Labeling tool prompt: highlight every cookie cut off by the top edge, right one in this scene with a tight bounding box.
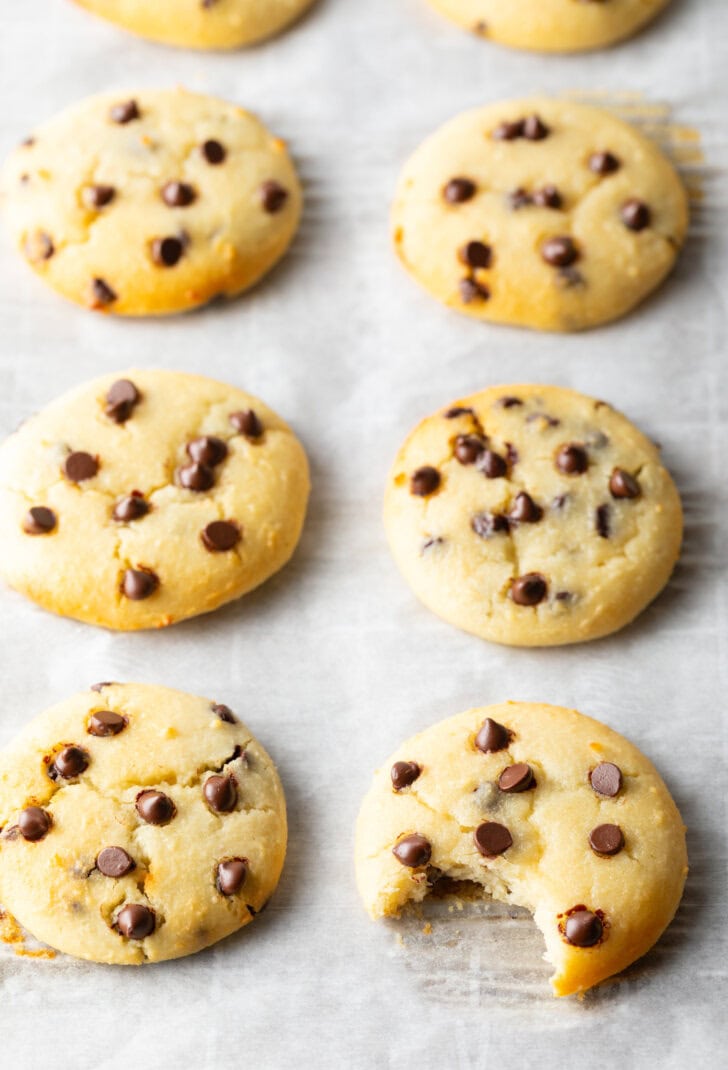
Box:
[429,0,669,52]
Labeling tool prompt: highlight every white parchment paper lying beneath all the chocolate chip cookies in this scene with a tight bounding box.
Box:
[0,0,728,1070]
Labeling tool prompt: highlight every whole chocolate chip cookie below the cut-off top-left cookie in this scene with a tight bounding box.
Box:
[2,89,302,316]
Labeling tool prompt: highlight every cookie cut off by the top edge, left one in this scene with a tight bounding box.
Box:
[71,0,314,48]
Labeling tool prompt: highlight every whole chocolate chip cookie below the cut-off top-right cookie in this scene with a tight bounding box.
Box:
[392,97,687,331]
